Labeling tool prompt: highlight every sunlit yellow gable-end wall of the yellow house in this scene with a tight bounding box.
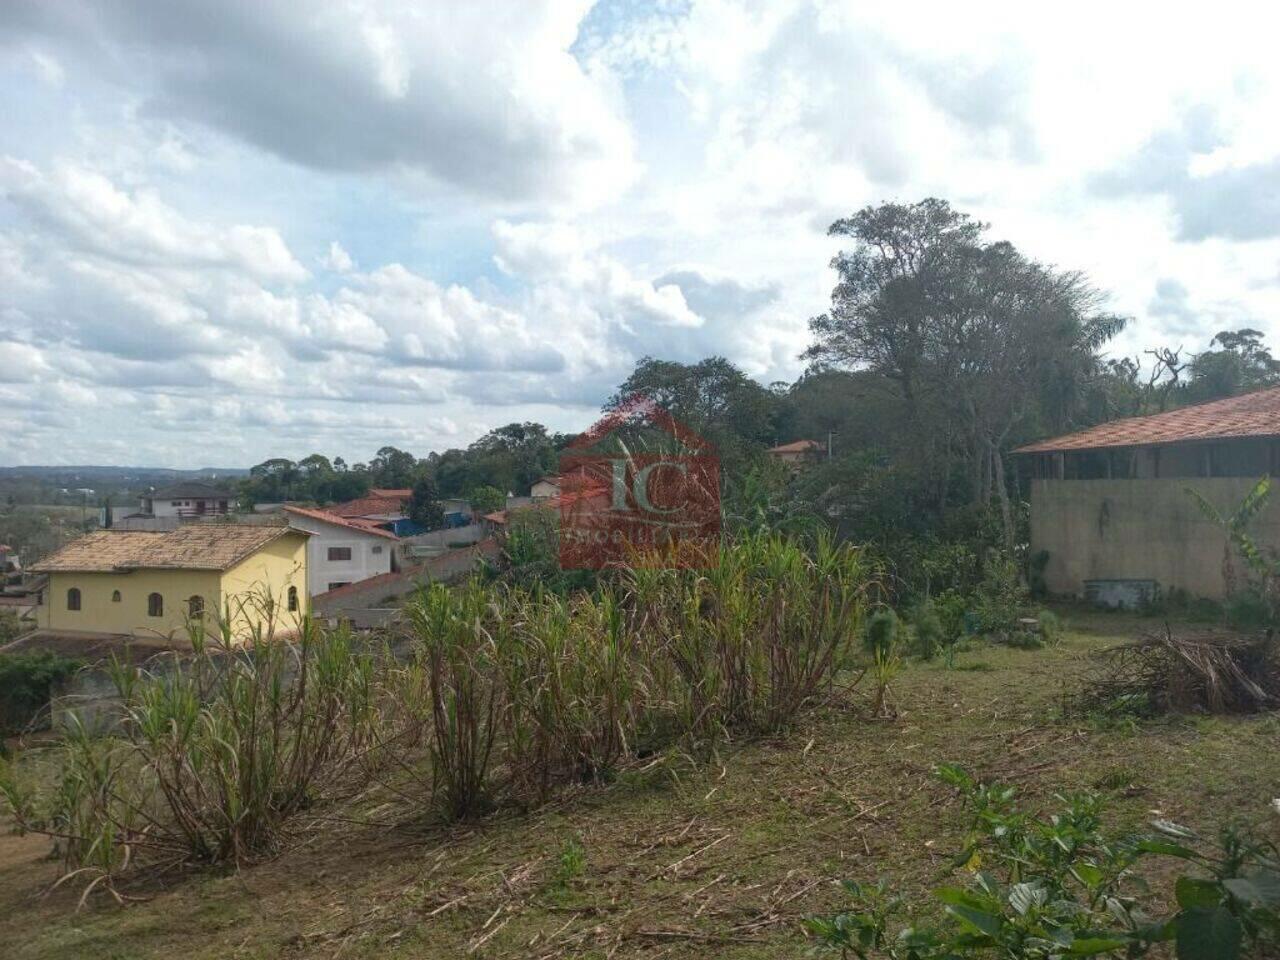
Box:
[220,530,311,639]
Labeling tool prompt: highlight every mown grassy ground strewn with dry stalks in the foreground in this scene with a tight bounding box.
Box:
[0,612,1280,960]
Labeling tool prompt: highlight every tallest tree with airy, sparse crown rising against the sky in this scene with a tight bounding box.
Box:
[805,198,1124,543]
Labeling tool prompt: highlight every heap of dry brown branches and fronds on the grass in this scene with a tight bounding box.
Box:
[1080,626,1280,714]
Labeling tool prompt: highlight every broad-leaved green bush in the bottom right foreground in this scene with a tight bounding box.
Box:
[805,765,1280,960]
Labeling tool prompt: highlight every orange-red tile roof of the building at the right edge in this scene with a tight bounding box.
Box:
[1015,387,1280,453]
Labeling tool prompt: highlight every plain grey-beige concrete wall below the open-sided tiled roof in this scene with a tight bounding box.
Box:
[1032,477,1280,599]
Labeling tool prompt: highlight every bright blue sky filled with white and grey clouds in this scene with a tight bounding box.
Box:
[0,0,1280,468]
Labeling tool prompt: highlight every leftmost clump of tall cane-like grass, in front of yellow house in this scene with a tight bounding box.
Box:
[6,598,376,876]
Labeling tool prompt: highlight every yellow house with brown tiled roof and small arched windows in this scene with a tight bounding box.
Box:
[31,524,311,640]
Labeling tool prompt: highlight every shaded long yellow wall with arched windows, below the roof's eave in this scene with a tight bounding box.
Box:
[37,570,219,637]
